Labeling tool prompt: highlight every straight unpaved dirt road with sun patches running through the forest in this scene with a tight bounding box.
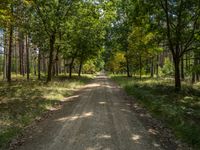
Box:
[17,74,162,150]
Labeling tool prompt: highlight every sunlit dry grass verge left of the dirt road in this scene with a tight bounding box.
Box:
[0,75,92,149]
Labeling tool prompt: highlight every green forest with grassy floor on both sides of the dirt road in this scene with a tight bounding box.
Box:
[0,0,200,149]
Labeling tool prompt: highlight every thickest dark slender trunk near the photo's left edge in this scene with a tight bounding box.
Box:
[7,25,13,82]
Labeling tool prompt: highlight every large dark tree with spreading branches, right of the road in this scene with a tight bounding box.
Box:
[159,0,200,91]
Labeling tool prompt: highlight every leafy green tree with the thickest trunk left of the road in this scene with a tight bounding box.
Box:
[31,0,75,82]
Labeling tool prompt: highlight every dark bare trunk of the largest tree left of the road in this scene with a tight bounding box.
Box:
[47,33,56,82]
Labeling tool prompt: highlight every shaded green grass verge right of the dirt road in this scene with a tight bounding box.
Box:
[111,75,200,149]
